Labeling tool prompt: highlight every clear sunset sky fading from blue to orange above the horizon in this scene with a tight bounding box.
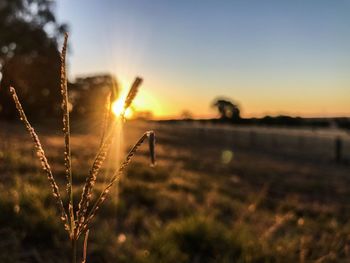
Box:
[56,0,350,118]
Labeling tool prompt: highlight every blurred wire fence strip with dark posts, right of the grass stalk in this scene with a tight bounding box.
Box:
[155,123,350,163]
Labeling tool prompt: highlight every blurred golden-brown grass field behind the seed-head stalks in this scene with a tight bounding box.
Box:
[0,122,350,263]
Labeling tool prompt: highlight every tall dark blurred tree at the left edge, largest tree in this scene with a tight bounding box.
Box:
[0,0,66,118]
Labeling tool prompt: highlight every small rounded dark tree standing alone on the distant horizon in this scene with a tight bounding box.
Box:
[212,98,241,122]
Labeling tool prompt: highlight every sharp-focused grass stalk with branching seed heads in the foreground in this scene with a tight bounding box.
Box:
[10,34,155,263]
